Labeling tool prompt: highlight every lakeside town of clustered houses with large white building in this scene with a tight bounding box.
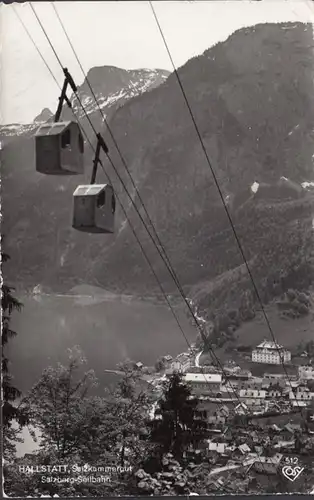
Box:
[129,340,314,492]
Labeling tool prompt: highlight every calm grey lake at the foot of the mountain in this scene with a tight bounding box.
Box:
[8,288,197,455]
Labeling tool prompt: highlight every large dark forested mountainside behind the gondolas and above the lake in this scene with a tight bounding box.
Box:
[3,23,314,320]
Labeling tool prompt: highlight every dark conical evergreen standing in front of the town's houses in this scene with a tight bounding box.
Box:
[151,373,206,461]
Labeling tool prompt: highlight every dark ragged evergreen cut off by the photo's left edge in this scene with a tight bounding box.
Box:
[1,248,27,459]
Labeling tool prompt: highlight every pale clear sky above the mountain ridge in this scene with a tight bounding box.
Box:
[0,0,314,124]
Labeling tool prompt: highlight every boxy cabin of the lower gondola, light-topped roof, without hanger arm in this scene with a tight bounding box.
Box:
[72,184,116,233]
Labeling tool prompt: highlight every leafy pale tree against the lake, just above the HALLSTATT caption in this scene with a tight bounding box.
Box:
[23,346,98,460]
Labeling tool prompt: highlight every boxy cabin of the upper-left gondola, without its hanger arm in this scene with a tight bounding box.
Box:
[35,121,84,175]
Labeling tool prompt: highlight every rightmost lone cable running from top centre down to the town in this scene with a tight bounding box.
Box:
[149,1,302,413]
